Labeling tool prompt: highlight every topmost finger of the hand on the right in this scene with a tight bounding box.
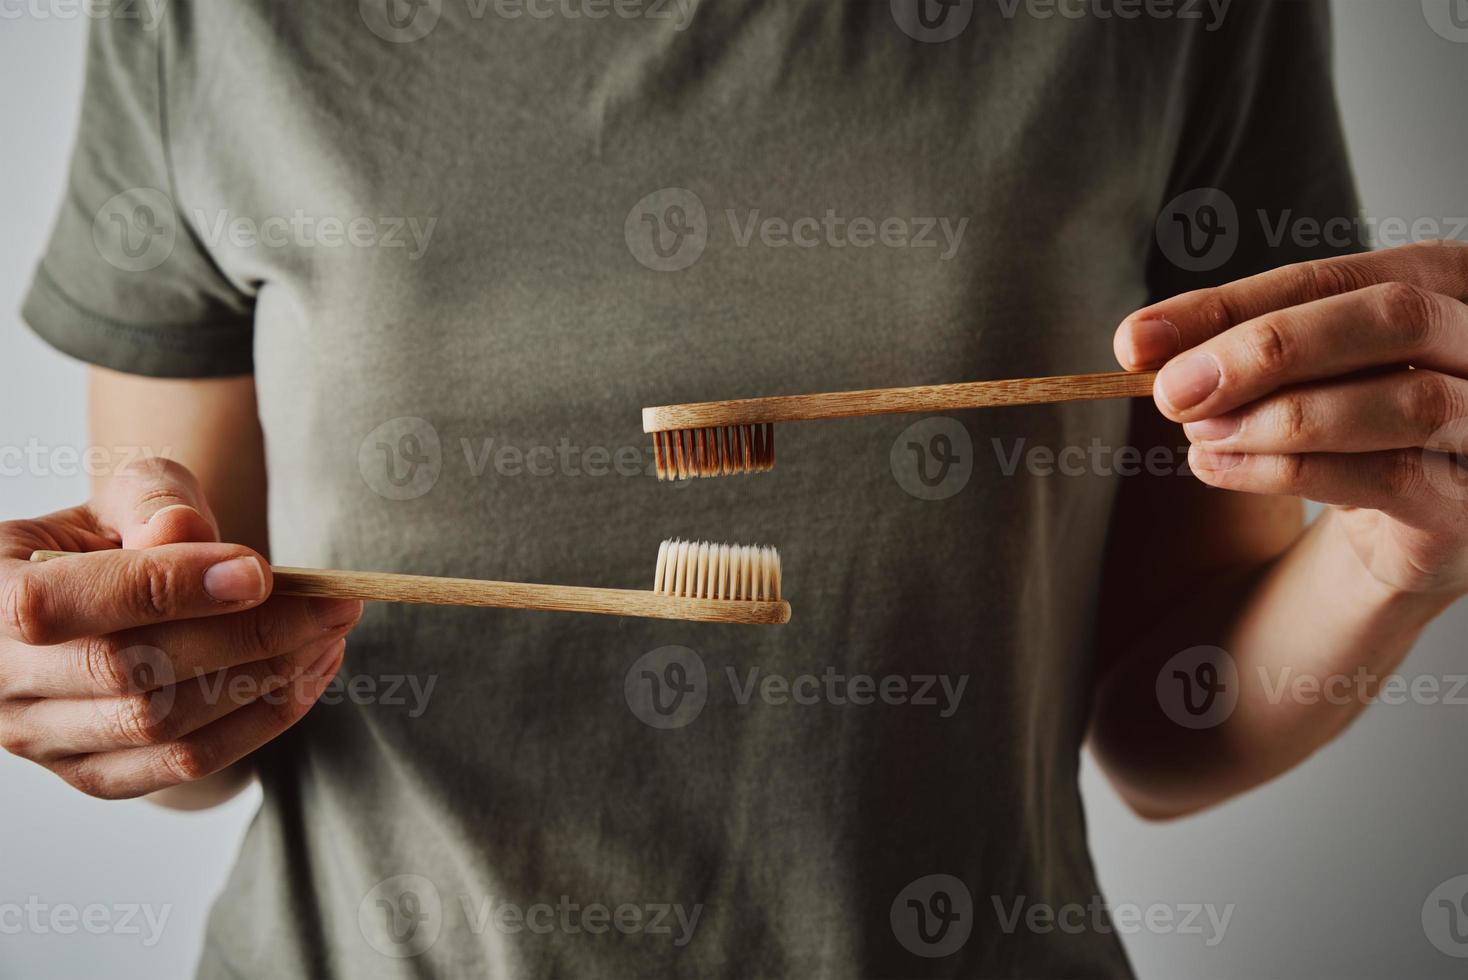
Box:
[1114,241,1468,371]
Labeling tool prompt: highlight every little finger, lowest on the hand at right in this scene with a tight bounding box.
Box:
[1188,446,1462,528]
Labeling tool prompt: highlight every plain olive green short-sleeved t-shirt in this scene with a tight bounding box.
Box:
[25,0,1356,979]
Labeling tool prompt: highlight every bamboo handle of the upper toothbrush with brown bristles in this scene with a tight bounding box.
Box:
[643,371,1157,433]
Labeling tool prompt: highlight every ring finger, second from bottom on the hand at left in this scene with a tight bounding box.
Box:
[0,635,345,764]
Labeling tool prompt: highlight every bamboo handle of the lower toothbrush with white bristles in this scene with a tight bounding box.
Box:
[31,552,790,625]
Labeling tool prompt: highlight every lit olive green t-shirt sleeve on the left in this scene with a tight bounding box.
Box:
[21,18,254,377]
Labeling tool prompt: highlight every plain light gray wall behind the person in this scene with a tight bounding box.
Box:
[0,0,1468,980]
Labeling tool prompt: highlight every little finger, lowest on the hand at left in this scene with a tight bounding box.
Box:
[50,646,342,800]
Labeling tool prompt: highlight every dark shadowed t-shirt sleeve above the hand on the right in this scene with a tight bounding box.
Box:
[1148,0,1367,299]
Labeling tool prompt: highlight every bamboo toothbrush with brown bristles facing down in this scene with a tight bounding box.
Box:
[643,371,1157,480]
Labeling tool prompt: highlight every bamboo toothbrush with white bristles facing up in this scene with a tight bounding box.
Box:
[31,538,790,625]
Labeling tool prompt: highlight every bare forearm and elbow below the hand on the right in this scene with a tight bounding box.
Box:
[1092,511,1456,817]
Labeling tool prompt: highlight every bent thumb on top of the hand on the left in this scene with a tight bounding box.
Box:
[92,456,219,549]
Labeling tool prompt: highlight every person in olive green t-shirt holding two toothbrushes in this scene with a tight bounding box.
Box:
[0,0,1468,977]
